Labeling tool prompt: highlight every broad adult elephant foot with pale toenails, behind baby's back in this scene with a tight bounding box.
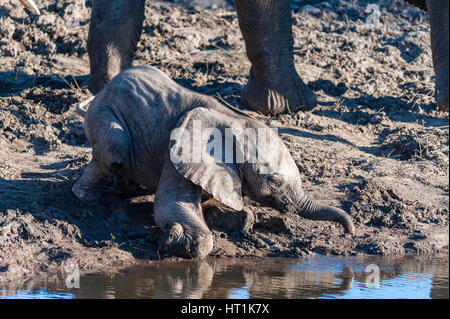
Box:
[242,70,317,115]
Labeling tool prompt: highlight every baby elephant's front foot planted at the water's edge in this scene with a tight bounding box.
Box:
[159,223,213,258]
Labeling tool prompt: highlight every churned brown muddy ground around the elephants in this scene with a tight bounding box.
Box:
[0,0,449,283]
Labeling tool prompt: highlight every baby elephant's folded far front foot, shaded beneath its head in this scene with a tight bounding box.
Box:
[202,203,255,233]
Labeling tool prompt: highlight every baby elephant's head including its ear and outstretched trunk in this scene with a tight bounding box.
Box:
[170,107,354,233]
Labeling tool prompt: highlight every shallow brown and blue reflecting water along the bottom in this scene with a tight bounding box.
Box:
[0,256,449,299]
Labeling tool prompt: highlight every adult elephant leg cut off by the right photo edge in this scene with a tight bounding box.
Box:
[427,0,449,112]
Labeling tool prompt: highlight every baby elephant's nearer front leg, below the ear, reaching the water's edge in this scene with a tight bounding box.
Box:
[153,160,213,258]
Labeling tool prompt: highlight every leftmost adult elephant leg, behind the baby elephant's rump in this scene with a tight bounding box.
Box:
[87,0,145,94]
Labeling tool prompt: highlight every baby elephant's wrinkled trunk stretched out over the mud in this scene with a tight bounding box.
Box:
[297,196,355,234]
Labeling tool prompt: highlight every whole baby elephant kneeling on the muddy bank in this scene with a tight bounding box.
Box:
[73,67,354,258]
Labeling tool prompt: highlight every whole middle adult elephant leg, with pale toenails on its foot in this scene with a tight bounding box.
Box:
[235,0,317,114]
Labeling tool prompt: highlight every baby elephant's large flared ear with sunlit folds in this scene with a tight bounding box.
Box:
[169,107,243,211]
